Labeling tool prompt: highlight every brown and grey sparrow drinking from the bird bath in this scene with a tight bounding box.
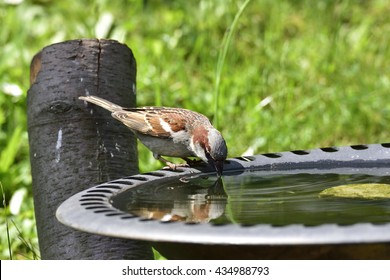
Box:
[79,95,227,176]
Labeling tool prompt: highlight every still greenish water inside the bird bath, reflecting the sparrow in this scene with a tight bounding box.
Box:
[111,171,390,226]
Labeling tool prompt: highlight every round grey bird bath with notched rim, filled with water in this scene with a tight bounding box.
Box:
[57,144,390,259]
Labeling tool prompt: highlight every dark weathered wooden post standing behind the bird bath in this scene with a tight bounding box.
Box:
[27,39,153,259]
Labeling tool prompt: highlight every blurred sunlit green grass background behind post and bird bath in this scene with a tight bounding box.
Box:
[0,0,390,259]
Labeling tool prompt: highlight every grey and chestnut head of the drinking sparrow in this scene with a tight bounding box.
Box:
[191,126,228,176]
